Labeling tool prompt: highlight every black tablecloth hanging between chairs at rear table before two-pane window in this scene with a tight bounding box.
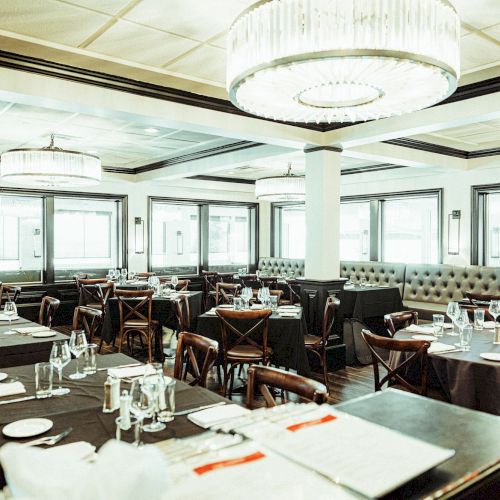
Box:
[95,292,203,343]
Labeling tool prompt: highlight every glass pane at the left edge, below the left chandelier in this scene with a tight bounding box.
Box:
[0,195,44,283]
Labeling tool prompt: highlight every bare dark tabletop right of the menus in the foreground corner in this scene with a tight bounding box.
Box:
[335,390,500,500]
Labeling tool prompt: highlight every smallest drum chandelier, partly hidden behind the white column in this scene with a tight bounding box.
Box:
[255,163,306,201]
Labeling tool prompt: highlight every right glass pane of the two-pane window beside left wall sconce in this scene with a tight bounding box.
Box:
[208,205,250,271]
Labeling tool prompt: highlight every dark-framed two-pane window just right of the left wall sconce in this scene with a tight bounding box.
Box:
[149,198,257,275]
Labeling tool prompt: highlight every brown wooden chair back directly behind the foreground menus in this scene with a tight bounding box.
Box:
[247,365,328,409]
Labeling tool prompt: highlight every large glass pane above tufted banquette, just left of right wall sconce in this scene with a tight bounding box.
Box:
[382,196,439,264]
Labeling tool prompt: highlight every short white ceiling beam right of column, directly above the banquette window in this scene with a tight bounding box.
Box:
[342,142,467,170]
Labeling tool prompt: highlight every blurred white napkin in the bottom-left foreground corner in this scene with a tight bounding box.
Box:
[0,440,169,500]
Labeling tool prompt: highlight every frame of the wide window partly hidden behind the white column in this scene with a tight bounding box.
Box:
[271,188,444,264]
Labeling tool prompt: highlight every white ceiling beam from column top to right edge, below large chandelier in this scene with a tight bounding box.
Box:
[323,92,500,149]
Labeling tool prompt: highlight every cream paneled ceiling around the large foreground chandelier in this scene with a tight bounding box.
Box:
[0,0,500,92]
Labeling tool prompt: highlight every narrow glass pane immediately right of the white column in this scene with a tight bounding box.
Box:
[340,201,370,260]
